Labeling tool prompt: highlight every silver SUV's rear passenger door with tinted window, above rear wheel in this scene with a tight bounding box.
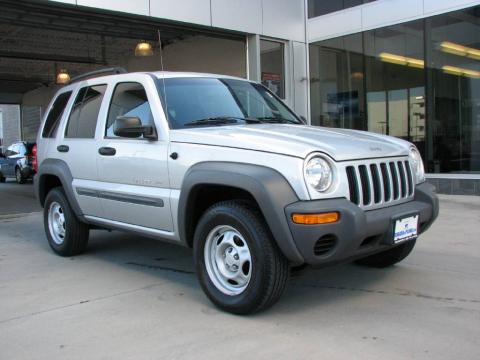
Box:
[51,80,107,217]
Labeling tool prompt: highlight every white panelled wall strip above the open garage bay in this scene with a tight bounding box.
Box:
[50,0,305,42]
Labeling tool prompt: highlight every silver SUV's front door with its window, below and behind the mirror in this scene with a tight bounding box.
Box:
[96,74,173,232]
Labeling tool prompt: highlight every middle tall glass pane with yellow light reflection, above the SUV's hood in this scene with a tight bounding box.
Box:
[364,20,425,152]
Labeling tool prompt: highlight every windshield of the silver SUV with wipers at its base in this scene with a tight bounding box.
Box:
[159,78,302,129]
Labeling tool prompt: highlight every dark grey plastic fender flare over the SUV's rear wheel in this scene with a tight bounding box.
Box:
[34,159,83,219]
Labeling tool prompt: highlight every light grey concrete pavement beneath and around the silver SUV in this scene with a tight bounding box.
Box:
[0,196,480,360]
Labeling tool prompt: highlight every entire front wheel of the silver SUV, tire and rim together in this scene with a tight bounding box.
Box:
[194,201,289,314]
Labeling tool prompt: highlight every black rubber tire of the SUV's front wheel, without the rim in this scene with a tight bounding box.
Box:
[194,201,290,314]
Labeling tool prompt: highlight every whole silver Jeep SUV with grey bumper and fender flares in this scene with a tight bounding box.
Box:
[35,72,438,314]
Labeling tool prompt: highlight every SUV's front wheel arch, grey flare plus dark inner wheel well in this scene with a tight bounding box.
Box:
[177,162,303,263]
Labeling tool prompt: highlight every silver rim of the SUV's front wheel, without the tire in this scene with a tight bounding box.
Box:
[204,225,252,296]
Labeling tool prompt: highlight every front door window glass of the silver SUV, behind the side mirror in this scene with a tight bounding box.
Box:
[105,82,154,137]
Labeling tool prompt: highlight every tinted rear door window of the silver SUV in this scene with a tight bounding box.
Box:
[65,85,107,139]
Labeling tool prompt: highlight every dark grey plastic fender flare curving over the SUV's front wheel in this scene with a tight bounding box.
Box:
[178,162,304,264]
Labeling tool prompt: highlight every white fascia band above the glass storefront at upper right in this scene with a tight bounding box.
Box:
[307,0,480,43]
